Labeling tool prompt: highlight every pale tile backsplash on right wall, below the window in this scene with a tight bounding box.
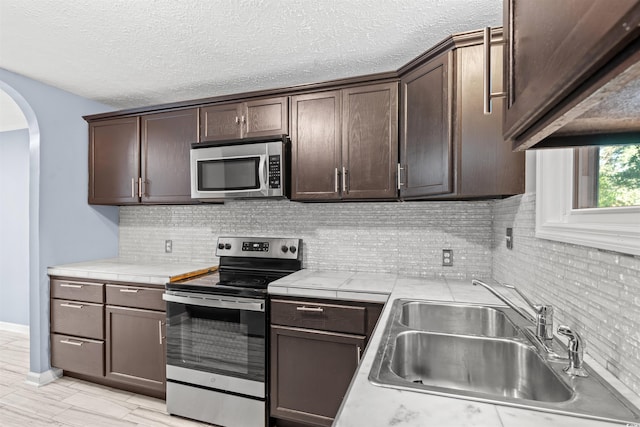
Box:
[493,194,640,394]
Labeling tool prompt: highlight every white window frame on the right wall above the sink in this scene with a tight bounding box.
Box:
[536,148,640,255]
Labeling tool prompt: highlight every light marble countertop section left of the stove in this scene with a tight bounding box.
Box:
[47,258,216,286]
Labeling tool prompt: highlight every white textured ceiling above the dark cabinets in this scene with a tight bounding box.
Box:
[0,0,502,108]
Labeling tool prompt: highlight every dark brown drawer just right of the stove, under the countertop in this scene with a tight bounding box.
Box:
[271,300,367,335]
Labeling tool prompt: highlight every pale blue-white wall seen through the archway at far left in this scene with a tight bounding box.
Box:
[0,129,29,325]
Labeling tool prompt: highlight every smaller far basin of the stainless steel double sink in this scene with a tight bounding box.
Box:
[400,301,518,337]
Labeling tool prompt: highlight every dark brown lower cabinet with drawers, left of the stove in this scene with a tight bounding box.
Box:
[50,277,166,399]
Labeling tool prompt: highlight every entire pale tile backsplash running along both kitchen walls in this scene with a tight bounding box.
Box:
[120,194,640,394]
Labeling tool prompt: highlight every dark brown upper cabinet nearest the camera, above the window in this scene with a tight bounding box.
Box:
[503,0,640,150]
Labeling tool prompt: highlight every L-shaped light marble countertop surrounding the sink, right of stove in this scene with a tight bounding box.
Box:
[269,270,640,427]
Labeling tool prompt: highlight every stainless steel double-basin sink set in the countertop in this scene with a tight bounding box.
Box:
[369,299,640,423]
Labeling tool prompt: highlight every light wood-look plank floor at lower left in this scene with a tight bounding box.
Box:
[0,330,208,427]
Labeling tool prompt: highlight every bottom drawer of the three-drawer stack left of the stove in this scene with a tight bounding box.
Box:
[51,334,104,377]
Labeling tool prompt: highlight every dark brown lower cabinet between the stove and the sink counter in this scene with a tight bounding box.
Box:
[270,298,382,427]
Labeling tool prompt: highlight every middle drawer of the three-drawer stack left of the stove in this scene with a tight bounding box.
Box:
[51,299,104,339]
